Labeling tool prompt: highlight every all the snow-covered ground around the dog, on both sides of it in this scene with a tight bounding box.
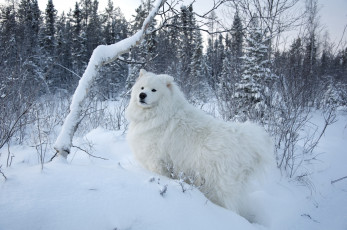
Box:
[0,110,347,230]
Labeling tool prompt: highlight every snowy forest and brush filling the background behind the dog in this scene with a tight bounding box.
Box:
[0,0,347,180]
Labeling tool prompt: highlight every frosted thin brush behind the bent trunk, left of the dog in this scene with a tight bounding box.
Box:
[0,91,128,167]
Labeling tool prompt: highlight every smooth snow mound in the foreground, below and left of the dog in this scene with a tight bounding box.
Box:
[0,129,256,230]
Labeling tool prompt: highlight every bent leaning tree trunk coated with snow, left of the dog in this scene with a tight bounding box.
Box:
[54,0,166,158]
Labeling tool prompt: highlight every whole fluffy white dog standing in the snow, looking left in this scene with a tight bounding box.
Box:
[126,70,273,220]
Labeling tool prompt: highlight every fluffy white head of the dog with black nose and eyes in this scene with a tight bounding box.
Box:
[131,69,173,109]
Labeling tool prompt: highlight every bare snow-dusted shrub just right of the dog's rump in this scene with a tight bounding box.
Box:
[263,74,336,179]
